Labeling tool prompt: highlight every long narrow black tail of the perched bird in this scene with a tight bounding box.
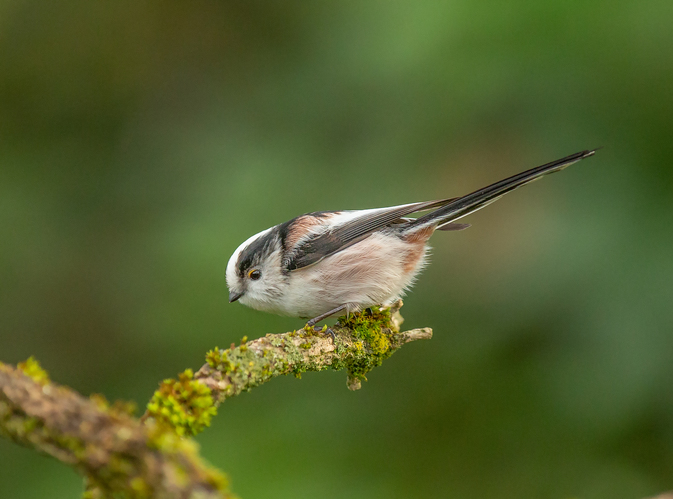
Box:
[412,149,598,227]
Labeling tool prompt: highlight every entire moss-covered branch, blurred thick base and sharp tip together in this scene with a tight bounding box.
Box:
[0,301,432,499]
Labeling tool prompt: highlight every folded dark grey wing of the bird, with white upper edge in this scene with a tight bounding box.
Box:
[284,198,456,271]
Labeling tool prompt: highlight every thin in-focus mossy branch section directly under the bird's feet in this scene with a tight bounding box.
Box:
[143,300,432,435]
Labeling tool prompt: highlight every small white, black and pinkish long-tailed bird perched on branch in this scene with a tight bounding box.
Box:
[226,149,598,326]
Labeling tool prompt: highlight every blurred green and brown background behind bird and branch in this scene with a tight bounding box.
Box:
[0,0,673,499]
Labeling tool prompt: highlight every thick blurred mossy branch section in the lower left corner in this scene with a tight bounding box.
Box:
[0,359,230,499]
